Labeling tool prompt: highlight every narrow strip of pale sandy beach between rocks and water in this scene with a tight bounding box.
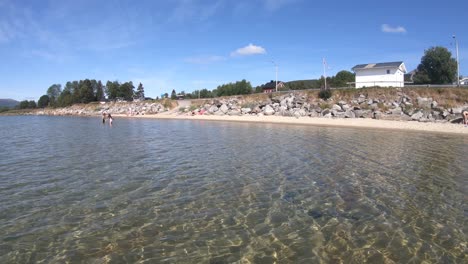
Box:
[117,113,468,135]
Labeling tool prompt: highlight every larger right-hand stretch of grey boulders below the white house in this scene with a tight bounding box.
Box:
[186,92,468,122]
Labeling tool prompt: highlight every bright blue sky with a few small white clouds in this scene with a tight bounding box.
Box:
[0,0,468,100]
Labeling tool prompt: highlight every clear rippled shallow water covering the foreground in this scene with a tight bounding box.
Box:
[0,117,468,263]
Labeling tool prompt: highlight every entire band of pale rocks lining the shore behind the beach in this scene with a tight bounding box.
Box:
[23,91,468,123]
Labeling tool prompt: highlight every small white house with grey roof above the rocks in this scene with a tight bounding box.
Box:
[352,61,406,88]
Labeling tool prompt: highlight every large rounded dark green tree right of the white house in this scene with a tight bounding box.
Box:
[415,46,457,84]
